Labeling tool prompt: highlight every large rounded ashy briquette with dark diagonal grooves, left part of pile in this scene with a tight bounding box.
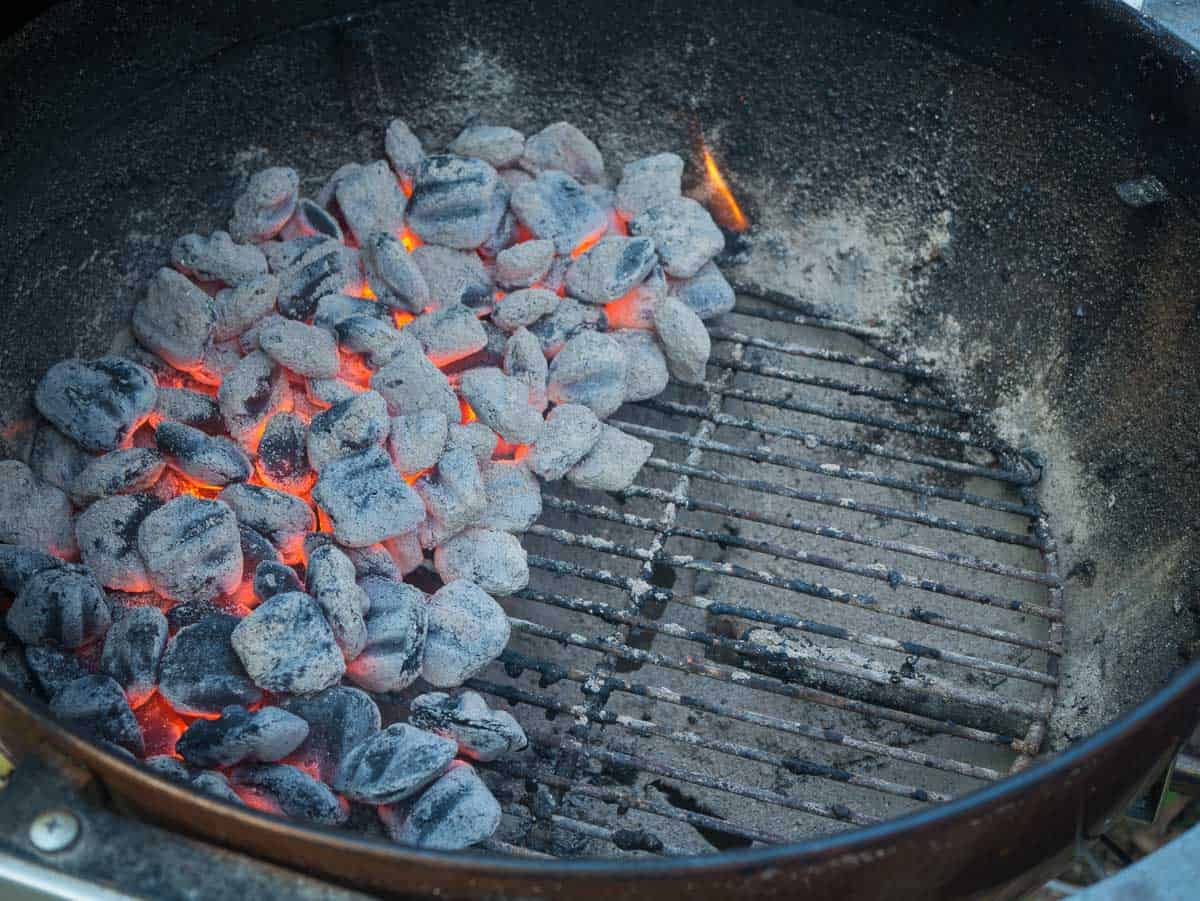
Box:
[138,494,242,601]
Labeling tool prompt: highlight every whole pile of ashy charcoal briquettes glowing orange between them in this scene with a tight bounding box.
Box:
[0,120,733,848]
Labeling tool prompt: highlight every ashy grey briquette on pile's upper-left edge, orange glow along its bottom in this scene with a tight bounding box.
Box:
[135,268,217,374]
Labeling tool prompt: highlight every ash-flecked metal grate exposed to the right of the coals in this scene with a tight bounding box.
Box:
[451,290,1063,855]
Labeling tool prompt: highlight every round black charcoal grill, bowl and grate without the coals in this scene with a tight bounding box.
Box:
[0,0,1200,897]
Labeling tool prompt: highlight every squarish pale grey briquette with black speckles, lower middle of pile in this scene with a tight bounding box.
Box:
[230,591,346,695]
